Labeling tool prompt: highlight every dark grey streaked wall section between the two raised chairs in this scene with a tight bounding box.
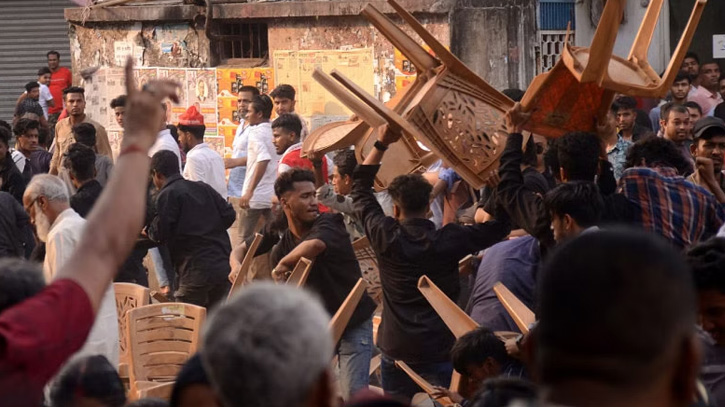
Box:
[450,0,538,89]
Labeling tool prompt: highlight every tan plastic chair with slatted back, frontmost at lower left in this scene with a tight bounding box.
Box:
[126,303,206,399]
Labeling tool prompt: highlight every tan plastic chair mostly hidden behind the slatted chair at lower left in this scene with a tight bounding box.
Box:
[113,283,151,381]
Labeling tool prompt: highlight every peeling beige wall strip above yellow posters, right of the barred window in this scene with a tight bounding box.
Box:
[268,14,450,100]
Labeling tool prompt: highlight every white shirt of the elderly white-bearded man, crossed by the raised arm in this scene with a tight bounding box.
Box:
[43,208,119,366]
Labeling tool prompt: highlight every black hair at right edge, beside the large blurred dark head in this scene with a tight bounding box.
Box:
[687,237,725,294]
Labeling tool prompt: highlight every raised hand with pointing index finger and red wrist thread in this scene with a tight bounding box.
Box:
[122,58,179,151]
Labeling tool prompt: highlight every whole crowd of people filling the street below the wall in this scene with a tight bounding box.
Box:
[0,47,725,407]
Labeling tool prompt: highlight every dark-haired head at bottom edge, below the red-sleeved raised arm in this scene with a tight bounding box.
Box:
[50,355,126,407]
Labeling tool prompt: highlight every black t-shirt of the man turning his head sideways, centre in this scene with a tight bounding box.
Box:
[272,213,375,327]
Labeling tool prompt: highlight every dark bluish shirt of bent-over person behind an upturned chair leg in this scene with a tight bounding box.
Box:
[466,236,541,332]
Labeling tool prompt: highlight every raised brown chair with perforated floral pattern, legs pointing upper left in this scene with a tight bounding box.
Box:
[306,0,513,188]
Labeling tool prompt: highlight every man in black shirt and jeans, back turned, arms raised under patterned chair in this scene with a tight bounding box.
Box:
[352,129,511,399]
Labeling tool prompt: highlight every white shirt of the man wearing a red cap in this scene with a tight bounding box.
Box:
[184,143,227,199]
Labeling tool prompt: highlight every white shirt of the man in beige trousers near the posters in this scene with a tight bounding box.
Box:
[242,122,279,209]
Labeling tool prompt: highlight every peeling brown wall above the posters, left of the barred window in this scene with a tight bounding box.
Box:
[69,23,210,81]
